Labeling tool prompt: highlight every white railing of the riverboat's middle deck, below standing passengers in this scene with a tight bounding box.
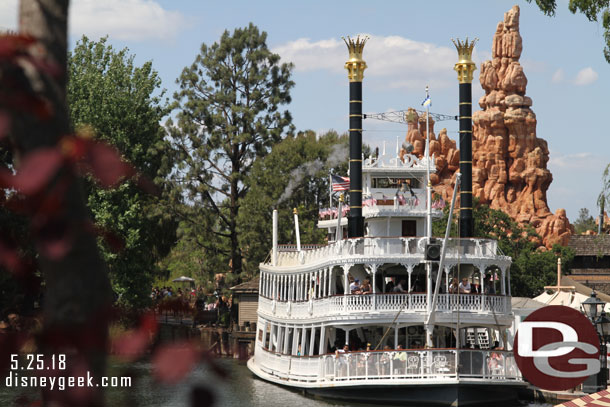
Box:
[258,293,511,319]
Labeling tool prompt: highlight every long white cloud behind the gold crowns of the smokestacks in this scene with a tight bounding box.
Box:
[273,34,464,90]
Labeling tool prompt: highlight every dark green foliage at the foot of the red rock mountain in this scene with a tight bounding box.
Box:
[433,200,574,298]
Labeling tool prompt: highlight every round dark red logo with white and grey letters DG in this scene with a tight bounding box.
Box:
[514,305,600,391]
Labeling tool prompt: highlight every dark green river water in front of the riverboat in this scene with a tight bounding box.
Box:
[0,359,551,407]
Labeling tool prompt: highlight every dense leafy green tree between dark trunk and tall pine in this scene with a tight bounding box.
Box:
[68,37,176,306]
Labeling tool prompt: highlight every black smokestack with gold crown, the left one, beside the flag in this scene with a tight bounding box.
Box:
[343,36,368,237]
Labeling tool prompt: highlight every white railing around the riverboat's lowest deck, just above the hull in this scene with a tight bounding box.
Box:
[255,348,521,384]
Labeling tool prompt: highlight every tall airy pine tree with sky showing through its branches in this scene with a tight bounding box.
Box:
[168,24,294,274]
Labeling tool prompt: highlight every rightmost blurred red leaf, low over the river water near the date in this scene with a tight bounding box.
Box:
[152,342,199,384]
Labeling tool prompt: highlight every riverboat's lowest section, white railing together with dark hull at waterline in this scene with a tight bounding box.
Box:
[248,348,525,407]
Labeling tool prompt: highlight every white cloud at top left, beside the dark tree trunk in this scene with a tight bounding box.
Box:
[0,0,187,41]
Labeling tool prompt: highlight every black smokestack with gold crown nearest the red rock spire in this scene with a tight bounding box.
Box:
[451,37,478,237]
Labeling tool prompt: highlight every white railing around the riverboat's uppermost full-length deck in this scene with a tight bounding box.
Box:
[268,237,498,267]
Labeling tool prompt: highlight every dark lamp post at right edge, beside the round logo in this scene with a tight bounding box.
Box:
[581,291,610,393]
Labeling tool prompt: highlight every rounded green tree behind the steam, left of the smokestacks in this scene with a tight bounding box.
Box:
[238,131,348,277]
